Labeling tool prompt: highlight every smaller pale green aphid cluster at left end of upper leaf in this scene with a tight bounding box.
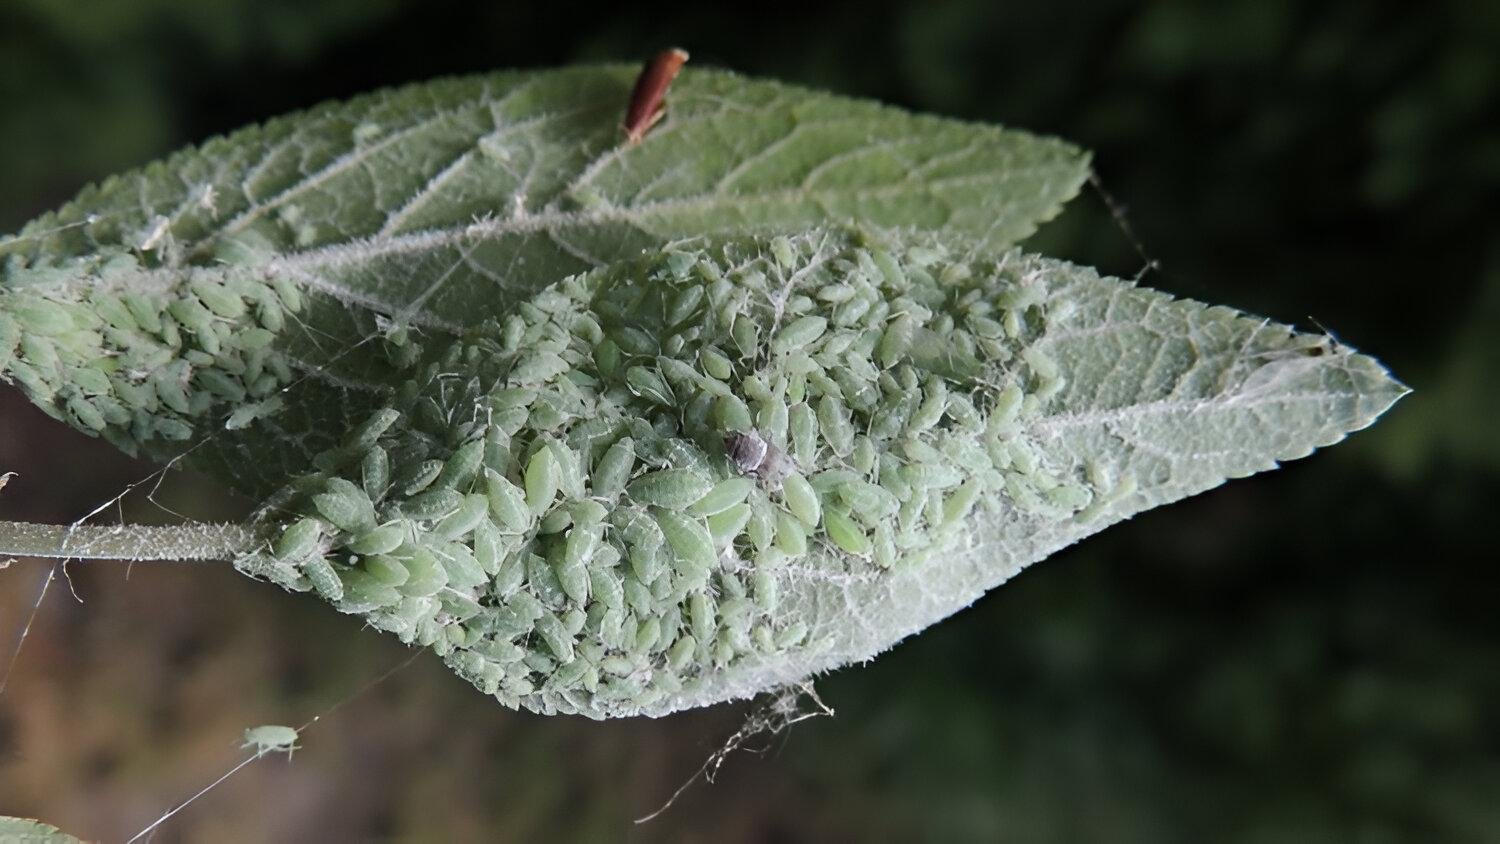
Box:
[0,252,303,454]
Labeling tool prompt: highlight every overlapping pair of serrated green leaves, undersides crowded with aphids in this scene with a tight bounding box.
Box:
[0,67,1404,717]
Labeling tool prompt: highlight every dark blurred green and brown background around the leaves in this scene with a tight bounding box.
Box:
[0,0,1500,844]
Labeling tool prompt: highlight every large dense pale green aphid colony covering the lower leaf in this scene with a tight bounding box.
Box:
[228,234,1095,717]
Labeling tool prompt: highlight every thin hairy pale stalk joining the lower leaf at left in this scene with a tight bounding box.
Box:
[0,522,266,561]
